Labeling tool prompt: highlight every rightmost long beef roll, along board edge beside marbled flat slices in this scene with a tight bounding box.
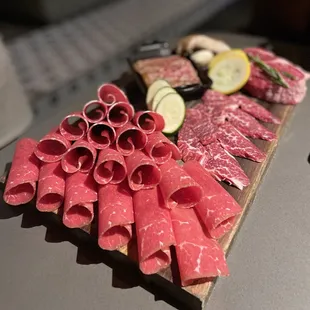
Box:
[183,161,242,239]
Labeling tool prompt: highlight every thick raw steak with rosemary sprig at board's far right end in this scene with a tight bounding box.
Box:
[245,48,310,104]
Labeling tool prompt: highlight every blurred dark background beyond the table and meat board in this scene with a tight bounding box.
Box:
[0,0,310,147]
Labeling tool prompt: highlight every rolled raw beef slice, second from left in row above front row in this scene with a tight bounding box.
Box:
[61,138,97,173]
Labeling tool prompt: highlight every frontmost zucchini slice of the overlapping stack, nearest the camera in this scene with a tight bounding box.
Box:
[156,93,186,134]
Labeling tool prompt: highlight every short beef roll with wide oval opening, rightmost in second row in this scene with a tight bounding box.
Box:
[159,159,202,209]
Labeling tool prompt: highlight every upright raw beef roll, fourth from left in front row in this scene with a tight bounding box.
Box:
[98,181,134,251]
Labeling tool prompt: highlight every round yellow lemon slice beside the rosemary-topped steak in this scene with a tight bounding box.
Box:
[209,50,251,94]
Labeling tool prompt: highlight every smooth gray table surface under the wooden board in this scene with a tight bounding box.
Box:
[0,35,310,310]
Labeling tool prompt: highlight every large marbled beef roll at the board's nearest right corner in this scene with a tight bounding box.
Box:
[171,208,229,286]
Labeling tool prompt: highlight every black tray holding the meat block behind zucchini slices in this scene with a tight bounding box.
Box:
[127,41,212,101]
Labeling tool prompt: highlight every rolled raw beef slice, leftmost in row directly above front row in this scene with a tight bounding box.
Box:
[34,130,71,163]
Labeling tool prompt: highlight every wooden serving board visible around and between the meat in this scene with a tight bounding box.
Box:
[0,77,294,309]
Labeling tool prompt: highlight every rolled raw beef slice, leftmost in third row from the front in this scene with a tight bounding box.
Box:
[59,112,89,141]
